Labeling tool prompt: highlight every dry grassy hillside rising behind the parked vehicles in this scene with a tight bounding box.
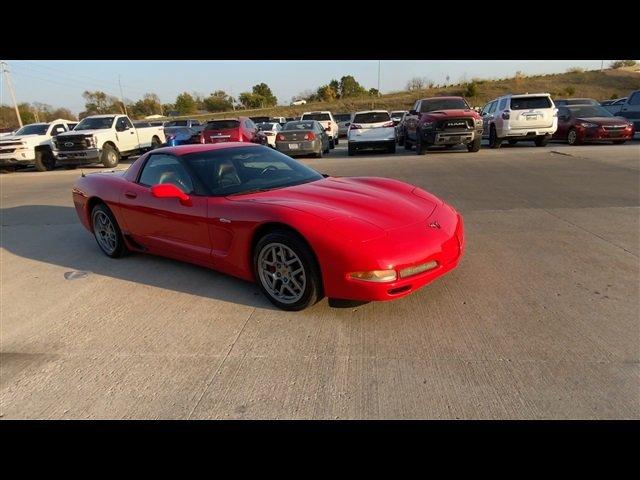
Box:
[166,69,640,123]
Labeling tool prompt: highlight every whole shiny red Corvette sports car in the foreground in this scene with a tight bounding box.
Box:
[73,142,464,310]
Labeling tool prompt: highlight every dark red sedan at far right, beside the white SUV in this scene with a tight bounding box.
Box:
[553,105,634,145]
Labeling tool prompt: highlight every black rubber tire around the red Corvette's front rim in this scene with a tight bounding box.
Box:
[253,230,323,312]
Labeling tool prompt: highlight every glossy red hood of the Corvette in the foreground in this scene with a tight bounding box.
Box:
[233,177,439,231]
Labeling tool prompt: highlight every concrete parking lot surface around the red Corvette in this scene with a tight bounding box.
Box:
[0,141,640,419]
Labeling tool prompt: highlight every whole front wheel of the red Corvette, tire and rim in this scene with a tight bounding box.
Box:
[253,230,322,311]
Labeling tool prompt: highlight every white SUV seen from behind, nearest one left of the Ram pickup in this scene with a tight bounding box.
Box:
[347,110,396,156]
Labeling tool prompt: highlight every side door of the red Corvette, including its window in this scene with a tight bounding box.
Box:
[120,153,211,263]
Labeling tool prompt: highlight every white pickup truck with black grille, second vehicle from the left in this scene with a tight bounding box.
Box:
[53,114,166,168]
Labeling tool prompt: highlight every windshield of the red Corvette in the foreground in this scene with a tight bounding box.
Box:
[182,146,323,195]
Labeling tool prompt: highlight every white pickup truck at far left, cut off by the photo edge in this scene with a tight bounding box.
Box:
[0,118,78,172]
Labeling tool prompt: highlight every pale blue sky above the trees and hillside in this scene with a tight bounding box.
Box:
[0,60,610,114]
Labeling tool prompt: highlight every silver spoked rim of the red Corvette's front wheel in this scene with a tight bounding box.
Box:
[258,243,307,304]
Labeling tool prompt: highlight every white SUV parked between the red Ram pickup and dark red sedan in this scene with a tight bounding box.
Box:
[482,93,558,148]
